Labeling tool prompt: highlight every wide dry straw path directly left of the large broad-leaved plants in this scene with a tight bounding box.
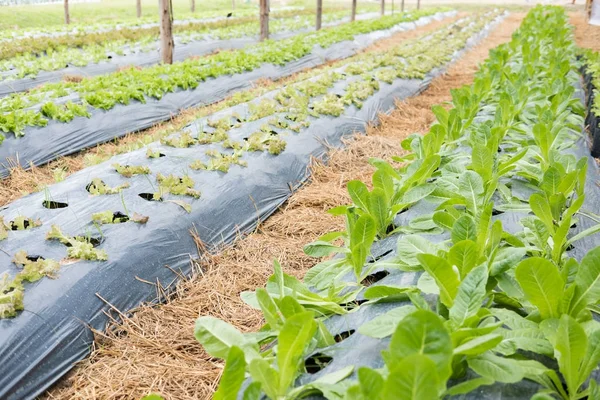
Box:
[46,10,524,400]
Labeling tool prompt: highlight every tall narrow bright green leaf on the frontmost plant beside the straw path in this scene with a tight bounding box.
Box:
[277,312,317,394]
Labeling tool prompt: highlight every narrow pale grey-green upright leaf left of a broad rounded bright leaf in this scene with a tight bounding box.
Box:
[449,265,488,327]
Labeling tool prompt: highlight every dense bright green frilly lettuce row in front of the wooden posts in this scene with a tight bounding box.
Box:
[0,10,446,142]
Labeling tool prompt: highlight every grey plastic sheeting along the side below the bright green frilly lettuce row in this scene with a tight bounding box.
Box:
[0,11,456,177]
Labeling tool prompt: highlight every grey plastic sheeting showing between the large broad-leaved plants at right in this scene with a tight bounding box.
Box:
[262,79,600,400]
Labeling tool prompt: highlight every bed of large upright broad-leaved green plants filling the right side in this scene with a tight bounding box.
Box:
[195,6,600,400]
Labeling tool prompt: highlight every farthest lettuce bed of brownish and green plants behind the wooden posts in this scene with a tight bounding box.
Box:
[0,10,368,81]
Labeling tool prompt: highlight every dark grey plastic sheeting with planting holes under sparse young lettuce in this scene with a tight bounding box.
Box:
[0,36,450,400]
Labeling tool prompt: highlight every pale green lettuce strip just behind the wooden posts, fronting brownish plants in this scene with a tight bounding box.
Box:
[0,11,370,80]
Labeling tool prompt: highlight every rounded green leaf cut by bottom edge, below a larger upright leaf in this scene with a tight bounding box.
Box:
[383,354,440,400]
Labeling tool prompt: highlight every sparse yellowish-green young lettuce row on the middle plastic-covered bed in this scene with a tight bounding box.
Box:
[0,12,499,318]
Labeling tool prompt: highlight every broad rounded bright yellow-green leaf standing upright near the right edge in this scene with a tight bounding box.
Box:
[515,257,565,319]
